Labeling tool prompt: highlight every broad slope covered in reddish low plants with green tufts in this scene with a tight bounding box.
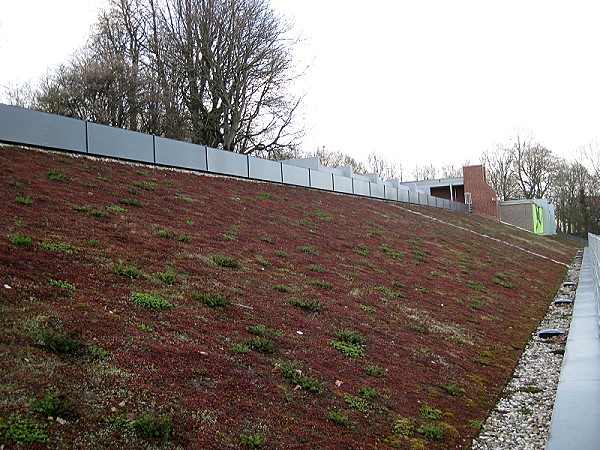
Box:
[0,147,574,448]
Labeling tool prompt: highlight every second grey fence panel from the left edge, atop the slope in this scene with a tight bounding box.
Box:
[88,122,154,163]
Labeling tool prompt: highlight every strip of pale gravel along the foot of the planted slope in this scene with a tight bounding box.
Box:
[471,253,581,450]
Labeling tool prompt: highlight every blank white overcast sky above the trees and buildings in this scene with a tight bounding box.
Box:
[0,0,600,174]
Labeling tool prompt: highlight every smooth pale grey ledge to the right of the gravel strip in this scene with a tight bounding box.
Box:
[546,247,600,450]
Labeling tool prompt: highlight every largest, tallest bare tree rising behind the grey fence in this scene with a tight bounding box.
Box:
[155,0,301,153]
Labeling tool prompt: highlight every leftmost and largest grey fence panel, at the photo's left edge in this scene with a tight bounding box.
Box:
[0,104,86,153]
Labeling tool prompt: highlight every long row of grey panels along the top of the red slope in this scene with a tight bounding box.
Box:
[0,104,468,211]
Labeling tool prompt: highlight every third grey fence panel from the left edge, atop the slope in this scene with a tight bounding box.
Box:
[154,136,206,170]
